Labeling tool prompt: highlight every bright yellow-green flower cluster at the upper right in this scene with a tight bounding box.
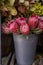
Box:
[30,2,43,16]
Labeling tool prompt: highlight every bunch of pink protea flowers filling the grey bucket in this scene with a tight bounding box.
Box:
[2,14,43,35]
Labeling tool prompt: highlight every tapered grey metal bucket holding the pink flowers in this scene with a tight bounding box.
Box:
[13,34,38,65]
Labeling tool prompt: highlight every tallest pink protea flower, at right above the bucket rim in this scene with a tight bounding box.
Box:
[28,14,38,29]
